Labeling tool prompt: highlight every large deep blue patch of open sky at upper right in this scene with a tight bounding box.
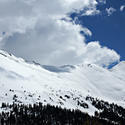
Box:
[72,0,125,60]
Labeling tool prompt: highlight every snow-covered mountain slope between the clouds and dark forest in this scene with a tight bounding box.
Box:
[0,50,125,115]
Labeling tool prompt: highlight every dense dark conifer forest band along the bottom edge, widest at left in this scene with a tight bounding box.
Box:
[0,103,123,125]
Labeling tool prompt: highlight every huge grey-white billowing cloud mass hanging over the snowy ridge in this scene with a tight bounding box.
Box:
[0,0,120,65]
